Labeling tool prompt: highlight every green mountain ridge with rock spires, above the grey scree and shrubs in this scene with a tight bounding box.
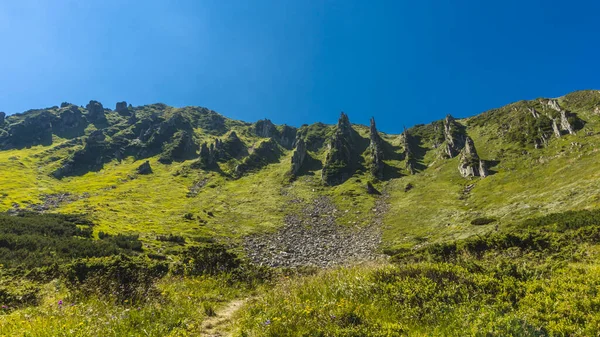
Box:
[0,90,600,253]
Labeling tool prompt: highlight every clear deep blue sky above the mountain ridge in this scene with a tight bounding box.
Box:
[0,0,600,133]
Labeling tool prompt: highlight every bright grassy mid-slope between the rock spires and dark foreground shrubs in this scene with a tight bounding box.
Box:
[0,92,600,253]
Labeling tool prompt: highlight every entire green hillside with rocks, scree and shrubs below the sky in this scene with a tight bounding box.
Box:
[0,90,600,336]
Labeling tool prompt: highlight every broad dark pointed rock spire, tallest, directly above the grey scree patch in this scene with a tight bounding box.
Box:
[321,112,356,185]
